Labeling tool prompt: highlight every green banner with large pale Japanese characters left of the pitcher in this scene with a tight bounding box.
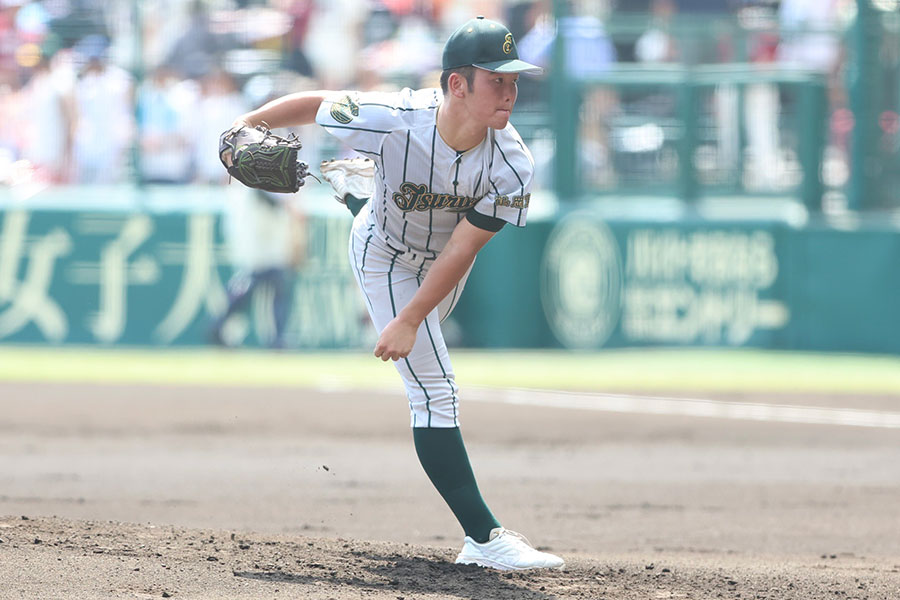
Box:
[0,209,372,348]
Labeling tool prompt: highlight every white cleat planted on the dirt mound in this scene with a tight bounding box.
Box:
[456,527,566,571]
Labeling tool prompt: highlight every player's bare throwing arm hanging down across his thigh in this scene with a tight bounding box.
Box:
[375,219,496,361]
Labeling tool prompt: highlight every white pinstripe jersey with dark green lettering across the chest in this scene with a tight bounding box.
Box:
[316,88,534,258]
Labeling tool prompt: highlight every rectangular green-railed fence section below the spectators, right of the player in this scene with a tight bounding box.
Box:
[553,64,826,210]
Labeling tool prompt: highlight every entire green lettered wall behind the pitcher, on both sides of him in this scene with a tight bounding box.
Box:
[0,190,900,353]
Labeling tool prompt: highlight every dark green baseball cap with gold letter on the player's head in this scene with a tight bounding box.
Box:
[442,17,543,74]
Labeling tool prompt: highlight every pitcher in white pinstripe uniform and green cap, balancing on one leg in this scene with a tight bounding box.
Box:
[225,17,563,570]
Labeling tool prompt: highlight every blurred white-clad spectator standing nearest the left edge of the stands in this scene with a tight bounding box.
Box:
[21,49,75,183]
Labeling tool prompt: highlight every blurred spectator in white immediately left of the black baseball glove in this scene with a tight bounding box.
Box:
[192,70,249,183]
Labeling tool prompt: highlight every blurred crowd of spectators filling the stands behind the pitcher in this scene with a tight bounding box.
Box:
[0,0,846,184]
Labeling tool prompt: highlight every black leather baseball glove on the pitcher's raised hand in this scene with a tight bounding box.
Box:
[219,126,309,194]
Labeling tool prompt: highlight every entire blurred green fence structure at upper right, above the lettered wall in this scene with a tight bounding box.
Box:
[547,0,900,212]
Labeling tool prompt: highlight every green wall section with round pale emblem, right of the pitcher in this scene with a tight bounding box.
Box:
[454,211,900,353]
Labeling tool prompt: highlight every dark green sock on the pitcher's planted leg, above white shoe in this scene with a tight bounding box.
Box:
[413,427,500,544]
